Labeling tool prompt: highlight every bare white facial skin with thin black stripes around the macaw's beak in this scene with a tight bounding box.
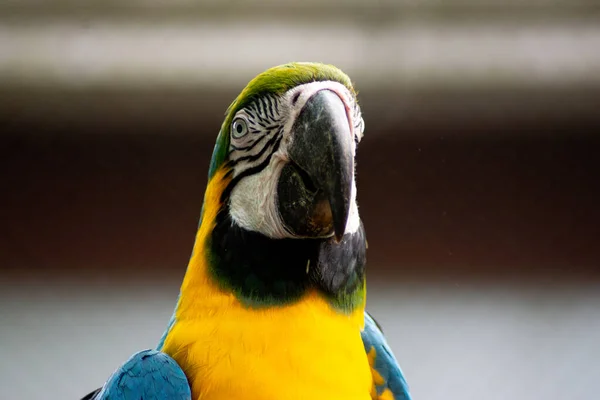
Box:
[230,81,364,239]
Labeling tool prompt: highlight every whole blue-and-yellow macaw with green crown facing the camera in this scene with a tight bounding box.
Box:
[83,62,411,400]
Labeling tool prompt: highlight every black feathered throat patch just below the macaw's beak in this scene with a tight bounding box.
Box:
[208,207,366,310]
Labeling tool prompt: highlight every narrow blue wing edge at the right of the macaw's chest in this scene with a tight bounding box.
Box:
[361,312,411,400]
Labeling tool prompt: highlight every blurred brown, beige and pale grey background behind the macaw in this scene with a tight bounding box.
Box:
[0,0,600,400]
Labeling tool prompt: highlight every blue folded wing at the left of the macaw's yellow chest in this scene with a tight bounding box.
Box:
[94,350,192,400]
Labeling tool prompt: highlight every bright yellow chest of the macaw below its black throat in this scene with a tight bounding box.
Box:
[163,294,372,400]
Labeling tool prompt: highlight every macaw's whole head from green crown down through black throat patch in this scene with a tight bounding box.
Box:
[191,63,366,310]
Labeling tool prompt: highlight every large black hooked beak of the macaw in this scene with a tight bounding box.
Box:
[277,90,354,242]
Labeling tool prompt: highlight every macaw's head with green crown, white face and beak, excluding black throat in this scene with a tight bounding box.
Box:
[210,63,364,241]
